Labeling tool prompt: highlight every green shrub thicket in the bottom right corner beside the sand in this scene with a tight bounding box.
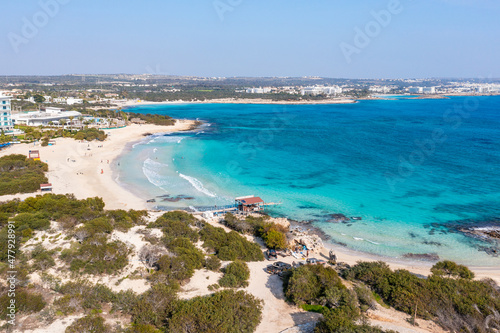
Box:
[344,261,500,332]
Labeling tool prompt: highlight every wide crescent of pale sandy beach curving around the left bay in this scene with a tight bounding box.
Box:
[0,120,194,210]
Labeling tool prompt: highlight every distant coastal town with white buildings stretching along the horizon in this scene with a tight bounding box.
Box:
[0,74,500,141]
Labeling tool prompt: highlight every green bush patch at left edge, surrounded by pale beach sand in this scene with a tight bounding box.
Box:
[0,155,48,195]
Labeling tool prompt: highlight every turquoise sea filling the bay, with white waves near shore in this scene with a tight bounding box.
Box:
[117,97,500,266]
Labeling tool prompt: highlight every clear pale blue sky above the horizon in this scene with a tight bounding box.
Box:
[0,0,500,78]
